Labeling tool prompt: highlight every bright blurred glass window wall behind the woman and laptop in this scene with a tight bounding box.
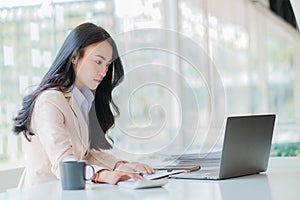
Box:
[0,0,300,168]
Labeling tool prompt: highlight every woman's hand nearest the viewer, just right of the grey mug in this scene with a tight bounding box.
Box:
[95,170,144,185]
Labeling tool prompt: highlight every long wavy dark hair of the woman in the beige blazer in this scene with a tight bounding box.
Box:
[12,23,124,141]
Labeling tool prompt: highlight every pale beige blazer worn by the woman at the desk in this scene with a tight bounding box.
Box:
[19,90,119,187]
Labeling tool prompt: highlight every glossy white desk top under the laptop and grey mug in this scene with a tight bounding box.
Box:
[0,157,300,200]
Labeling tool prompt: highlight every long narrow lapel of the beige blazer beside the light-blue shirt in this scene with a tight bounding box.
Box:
[65,92,89,153]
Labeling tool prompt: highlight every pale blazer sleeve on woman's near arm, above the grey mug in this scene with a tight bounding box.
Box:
[31,93,79,177]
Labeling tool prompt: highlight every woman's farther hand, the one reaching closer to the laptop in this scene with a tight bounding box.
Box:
[114,161,154,174]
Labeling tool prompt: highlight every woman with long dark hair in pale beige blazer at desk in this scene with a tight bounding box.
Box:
[13,23,154,186]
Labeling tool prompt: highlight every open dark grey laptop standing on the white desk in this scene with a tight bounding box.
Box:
[171,114,276,180]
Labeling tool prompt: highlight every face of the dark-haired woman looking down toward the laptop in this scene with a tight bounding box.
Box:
[72,41,113,90]
